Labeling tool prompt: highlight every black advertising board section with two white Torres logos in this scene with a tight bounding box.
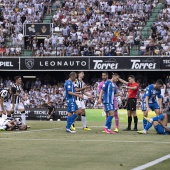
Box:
[90,57,160,70]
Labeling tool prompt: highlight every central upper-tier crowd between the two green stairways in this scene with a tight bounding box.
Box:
[34,0,158,56]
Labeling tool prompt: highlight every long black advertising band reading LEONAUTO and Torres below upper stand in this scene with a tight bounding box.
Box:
[0,56,170,71]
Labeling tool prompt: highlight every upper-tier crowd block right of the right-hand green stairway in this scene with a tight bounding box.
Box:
[139,0,170,56]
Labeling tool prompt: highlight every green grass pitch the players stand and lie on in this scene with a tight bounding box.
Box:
[0,110,170,170]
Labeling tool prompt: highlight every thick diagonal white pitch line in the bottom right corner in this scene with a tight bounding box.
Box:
[131,154,170,170]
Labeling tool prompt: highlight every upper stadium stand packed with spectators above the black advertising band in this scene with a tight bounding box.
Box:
[0,0,166,57]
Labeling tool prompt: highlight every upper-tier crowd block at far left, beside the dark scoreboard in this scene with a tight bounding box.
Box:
[0,0,51,56]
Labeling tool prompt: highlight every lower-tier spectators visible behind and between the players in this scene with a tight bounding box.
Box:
[0,78,170,110]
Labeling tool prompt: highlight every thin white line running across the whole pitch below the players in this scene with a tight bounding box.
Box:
[0,138,170,144]
